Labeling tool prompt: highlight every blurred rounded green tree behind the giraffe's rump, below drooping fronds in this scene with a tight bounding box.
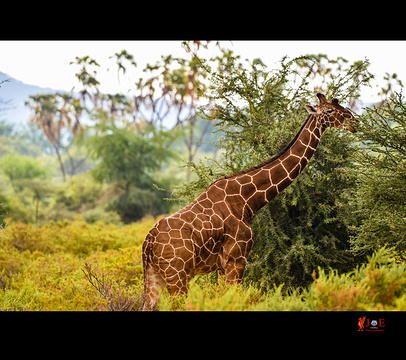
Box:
[87,127,171,223]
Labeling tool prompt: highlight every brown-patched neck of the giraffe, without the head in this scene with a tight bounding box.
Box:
[235,115,324,218]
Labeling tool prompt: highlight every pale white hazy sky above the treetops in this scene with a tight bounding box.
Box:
[0,41,406,102]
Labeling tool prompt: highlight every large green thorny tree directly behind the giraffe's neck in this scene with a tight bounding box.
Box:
[175,55,371,287]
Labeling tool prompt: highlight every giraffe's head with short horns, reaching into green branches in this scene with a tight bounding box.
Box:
[305,93,358,133]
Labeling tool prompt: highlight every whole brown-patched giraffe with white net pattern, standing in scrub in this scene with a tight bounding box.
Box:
[142,93,358,310]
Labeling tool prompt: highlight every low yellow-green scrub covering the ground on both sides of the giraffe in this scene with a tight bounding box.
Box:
[0,218,406,311]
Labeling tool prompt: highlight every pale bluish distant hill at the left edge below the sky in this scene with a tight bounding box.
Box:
[0,72,60,127]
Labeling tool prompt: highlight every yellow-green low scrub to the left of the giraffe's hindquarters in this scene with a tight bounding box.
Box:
[0,218,156,311]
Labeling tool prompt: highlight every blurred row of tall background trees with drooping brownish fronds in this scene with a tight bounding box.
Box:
[26,41,225,188]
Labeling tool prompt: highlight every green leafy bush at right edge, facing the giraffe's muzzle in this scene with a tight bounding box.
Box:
[347,93,406,258]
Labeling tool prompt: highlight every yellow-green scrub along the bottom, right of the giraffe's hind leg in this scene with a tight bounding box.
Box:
[159,248,406,311]
